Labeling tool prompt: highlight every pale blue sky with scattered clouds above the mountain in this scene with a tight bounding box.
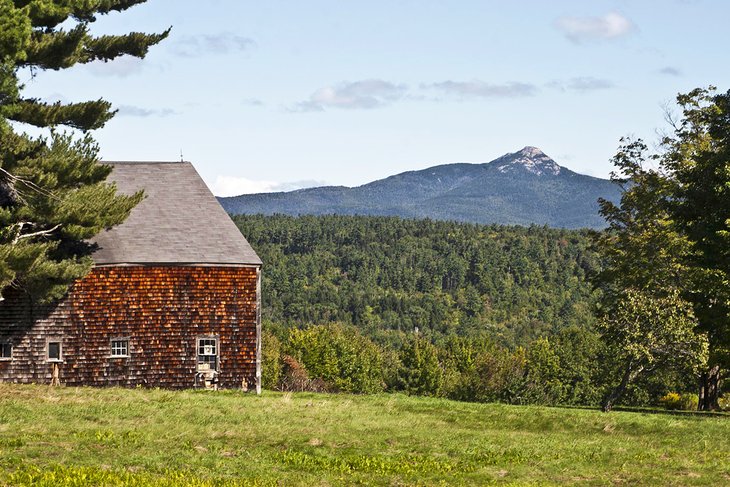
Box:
[15,0,730,196]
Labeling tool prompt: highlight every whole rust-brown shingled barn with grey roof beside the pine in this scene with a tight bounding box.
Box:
[0,162,261,392]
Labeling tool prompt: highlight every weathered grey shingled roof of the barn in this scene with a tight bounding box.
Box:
[92,162,261,265]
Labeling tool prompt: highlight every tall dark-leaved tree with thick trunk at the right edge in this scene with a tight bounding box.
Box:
[658,87,730,409]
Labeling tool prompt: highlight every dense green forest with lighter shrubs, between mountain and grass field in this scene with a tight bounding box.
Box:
[234,215,693,405]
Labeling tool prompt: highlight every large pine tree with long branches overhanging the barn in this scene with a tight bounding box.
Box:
[0,0,167,300]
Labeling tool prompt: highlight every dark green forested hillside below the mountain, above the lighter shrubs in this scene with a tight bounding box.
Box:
[234,215,596,347]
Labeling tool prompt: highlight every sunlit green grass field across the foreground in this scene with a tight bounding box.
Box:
[0,384,730,486]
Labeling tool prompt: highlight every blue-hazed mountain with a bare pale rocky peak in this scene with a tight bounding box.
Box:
[219,147,620,228]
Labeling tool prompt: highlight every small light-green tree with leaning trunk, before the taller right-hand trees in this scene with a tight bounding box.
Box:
[599,289,708,411]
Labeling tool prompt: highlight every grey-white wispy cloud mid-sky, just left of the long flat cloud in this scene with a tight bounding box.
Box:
[289,79,407,112]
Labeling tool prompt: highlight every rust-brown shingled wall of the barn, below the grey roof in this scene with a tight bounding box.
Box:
[0,265,260,389]
